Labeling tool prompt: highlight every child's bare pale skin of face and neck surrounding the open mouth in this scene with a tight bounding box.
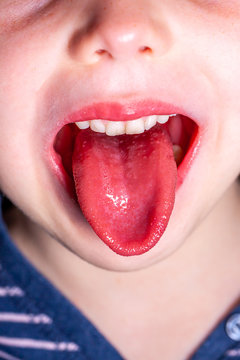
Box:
[0,0,240,360]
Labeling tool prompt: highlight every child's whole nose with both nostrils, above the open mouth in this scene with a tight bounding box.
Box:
[70,0,172,64]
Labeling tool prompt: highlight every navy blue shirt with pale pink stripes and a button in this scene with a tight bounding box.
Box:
[0,199,240,360]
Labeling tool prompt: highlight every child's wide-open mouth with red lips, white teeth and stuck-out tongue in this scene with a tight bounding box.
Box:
[53,104,200,256]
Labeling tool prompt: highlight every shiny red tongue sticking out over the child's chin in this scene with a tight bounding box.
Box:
[72,125,177,256]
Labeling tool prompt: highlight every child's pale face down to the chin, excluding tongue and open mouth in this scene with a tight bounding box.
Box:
[0,0,240,270]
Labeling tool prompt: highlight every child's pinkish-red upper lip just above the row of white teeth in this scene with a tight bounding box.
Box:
[39,97,202,152]
